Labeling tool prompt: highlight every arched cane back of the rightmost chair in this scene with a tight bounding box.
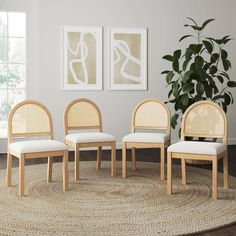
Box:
[181,101,227,144]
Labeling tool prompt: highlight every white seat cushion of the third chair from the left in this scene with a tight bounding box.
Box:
[122,132,170,143]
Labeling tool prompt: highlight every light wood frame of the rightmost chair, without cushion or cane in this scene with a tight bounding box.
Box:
[167,100,229,200]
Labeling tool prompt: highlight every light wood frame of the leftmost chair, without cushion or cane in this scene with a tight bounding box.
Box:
[7,100,68,197]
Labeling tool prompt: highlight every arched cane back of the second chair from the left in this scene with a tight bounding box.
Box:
[64,98,102,135]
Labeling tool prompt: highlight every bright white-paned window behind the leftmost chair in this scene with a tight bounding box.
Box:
[0,12,26,137]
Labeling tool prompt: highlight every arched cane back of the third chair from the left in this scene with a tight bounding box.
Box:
[132,99,170,134]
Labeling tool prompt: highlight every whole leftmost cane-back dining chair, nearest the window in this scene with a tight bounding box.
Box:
[7,100,68,197]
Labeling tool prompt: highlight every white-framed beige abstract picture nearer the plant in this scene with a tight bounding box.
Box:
[108,27,147,90]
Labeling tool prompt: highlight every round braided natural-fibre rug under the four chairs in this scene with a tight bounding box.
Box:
[0,161,236,236]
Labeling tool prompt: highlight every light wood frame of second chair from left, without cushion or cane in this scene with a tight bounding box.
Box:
[64,98,117,180]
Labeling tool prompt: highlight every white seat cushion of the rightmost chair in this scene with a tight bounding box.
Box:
[167,141,226,155]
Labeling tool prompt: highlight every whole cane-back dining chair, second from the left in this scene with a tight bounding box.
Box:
[64,98,116,180]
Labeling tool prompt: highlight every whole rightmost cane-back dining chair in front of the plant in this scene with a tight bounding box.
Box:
[167,101,228,199]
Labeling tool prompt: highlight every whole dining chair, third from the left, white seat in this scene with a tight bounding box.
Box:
[122,99,171,180]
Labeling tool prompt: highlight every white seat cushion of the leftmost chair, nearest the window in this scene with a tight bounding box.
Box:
[9,140,68,153]
